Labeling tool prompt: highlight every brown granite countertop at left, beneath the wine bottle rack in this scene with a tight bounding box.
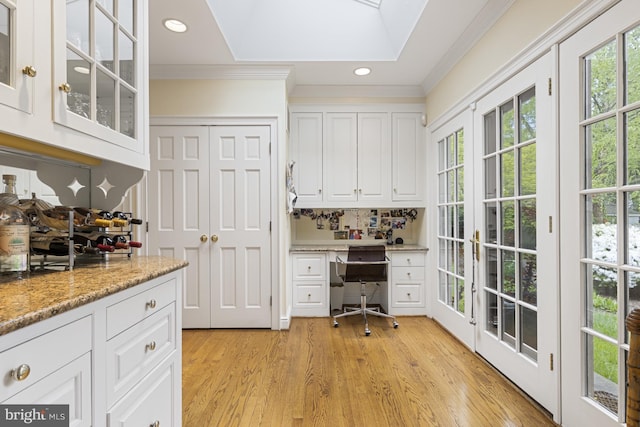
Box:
[0,256,188,335]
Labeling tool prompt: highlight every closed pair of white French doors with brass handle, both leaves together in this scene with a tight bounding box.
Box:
[432,54,559,416]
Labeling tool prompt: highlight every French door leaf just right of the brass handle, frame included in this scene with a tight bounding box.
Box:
[472,54,559,416]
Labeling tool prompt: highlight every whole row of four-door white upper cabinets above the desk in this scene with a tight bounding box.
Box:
[290,105,426,208]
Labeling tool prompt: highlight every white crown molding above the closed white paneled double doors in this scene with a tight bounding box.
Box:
[149,64,292,80]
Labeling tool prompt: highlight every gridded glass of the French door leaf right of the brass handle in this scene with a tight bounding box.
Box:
[483,87,538,361]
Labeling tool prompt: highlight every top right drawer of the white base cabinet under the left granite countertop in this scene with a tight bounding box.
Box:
[107,279,176,339]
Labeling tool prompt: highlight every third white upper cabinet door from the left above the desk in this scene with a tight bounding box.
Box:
[358,113,391,202]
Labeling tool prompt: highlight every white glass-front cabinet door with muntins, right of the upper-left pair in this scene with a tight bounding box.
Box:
[52,0,144,151]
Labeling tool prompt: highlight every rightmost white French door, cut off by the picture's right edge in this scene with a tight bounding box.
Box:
[559,0,640,426]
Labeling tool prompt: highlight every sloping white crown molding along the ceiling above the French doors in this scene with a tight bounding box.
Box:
[422,0,515,93]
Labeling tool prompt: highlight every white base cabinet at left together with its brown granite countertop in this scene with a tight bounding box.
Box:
[0,256,187,426]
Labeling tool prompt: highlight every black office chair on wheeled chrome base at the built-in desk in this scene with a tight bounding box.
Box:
[333,245,398,336]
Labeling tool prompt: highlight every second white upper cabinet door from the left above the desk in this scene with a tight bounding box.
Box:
[323,113,358,202]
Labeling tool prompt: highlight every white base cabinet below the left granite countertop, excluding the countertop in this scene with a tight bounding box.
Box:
[0,271,182,427]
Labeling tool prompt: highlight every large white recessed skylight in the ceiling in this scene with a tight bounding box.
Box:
[207,0,428,62]
